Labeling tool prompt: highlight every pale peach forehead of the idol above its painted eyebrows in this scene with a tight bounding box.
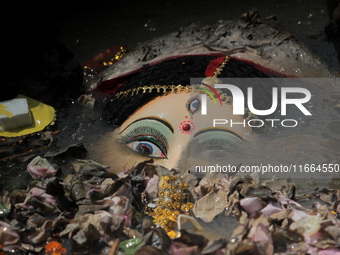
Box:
[116,93,251,136]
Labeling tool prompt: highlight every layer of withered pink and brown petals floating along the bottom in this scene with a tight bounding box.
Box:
[0,152,340,255]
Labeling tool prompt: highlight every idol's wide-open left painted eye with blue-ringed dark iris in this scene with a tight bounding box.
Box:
[126,141,166,158]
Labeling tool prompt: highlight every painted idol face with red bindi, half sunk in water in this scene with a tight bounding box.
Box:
[93,92,253,173]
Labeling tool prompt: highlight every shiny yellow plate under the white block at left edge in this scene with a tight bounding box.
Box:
[0,95,55,137]
